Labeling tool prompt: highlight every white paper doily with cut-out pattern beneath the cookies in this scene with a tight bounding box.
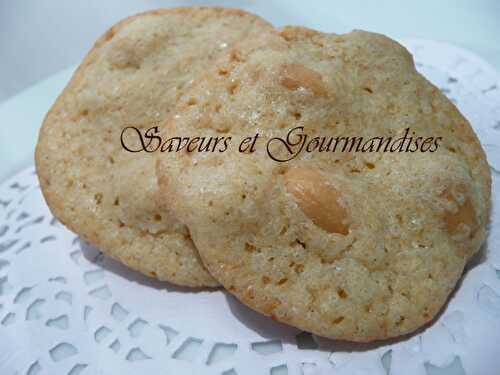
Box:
[0,40,500,375]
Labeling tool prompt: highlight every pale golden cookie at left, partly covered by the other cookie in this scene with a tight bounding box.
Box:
[36,8,271,286]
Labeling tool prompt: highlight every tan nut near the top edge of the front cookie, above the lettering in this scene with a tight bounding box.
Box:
[280,64,327,96]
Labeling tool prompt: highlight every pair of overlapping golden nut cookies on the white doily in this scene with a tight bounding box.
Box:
[36,8,491,341]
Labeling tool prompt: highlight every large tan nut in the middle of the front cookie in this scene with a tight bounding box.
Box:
[284,168,349,235]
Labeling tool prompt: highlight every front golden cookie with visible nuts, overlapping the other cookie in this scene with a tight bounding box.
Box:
[157,27,491,342]
